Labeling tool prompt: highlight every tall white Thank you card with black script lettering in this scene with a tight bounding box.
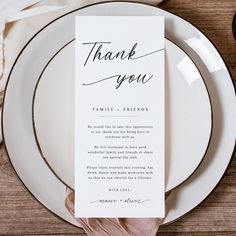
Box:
[74,16,165,218]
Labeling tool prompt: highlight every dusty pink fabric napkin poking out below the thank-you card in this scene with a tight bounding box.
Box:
[65,190,163,236]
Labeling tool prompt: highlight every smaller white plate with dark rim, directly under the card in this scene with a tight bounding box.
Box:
[33,38,212,191]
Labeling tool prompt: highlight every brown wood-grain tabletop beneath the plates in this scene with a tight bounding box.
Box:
[0,0,236,236]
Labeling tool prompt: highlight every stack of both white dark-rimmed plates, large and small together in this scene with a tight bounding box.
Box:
[2,2,236,226]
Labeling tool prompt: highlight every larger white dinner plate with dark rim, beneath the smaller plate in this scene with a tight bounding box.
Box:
[2,2,236,226]
